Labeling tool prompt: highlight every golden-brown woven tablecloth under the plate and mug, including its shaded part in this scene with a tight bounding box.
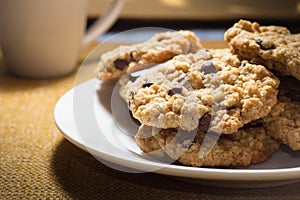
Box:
[0,43,300,200]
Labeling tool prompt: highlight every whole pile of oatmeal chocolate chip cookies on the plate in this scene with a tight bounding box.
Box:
[98,20,300,167]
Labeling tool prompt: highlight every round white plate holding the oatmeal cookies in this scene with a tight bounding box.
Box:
[54,79,300,187]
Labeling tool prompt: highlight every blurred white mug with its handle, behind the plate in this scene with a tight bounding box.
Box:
[0,0,124,78]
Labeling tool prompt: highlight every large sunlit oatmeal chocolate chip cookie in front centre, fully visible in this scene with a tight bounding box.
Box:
[125,49,279,134]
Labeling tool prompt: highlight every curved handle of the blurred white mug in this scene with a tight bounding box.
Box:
[82,0,124,48]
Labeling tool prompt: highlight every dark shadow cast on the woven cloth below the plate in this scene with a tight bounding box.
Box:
[52,139,300,200]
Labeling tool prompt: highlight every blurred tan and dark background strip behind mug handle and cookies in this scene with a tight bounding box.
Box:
[88,0,300,32]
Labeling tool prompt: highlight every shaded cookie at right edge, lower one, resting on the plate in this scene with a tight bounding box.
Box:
[263,97,300,150]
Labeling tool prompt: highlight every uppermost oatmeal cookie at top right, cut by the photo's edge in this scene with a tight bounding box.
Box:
[224,20,300,80]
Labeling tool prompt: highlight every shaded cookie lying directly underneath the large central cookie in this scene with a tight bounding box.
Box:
[137,127,279,167]
